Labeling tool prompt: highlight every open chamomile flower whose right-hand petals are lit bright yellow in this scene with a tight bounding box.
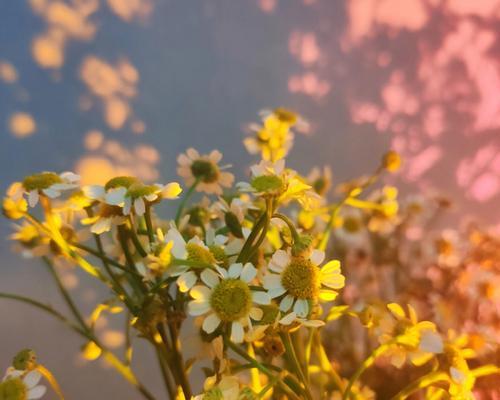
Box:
[264,250,345,318]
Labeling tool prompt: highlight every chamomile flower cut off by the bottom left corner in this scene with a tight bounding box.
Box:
[0,368,47,400]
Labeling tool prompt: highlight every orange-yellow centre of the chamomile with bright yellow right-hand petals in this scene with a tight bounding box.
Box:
[281,257,320,299]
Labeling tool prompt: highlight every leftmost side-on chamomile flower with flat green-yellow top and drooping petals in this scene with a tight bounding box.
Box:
[7,172,80,207]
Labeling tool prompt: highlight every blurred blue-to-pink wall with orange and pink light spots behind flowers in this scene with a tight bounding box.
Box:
[0,0,500,400]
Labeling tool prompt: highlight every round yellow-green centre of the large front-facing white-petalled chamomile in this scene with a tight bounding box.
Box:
[210,279,252,322]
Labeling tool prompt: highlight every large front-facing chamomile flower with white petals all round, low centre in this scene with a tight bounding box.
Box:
[188,263,271,343]
